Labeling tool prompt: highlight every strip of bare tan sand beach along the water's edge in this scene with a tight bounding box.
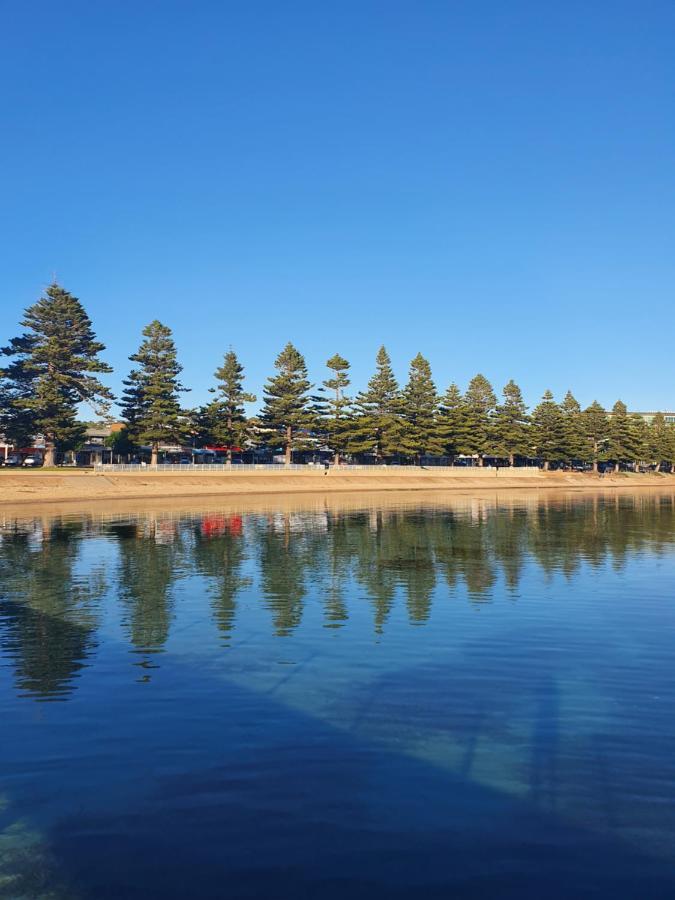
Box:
[0,468,675,510]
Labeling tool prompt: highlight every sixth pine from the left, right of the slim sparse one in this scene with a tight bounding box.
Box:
[349,347,403,460]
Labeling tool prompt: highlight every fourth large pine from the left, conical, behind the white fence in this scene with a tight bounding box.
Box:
[260,342,312,465]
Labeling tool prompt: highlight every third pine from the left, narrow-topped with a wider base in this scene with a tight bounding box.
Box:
[199,350,256,464]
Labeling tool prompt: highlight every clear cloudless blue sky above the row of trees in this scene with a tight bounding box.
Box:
[0,0,675,409]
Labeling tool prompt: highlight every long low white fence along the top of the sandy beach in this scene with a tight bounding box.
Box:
[94,463,540,478]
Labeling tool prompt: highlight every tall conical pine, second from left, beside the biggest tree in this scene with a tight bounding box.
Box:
[122,319,187,466]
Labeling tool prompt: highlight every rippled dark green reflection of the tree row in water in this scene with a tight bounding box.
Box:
[0,494,675,699]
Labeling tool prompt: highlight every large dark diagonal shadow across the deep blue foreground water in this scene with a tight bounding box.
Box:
[37,660,675,900]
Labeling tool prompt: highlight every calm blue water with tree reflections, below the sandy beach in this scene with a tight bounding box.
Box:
[0,494,675,900]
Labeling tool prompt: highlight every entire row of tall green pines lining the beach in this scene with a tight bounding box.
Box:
[0,284,675,471]
